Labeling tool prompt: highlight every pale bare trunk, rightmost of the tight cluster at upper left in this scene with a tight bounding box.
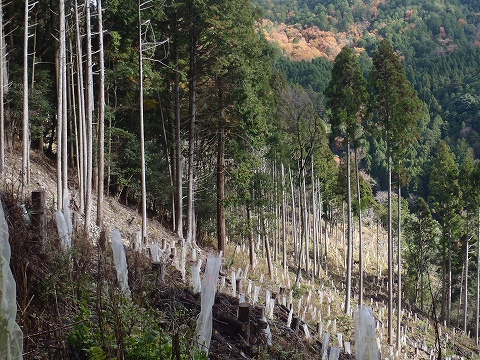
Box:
[97,0,105,227]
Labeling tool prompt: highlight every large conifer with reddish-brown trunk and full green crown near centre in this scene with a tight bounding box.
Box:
[201,0,269,252]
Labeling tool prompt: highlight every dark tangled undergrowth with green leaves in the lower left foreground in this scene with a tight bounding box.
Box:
[1,193,206,360]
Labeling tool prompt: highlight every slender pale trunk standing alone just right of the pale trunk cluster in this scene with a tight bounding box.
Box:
[138,0,147,244]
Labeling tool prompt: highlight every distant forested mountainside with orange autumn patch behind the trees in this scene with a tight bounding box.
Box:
[253,0,480,170]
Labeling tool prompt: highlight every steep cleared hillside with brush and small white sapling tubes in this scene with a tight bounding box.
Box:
[0,148,480,359]
